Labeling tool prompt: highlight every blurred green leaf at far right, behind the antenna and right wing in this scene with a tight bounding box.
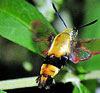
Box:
[78,0,100,71]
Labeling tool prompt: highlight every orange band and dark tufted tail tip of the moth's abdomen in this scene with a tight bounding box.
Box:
[37,64,60,89]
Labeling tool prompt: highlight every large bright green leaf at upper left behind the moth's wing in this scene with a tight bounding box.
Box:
[0,0,56,55]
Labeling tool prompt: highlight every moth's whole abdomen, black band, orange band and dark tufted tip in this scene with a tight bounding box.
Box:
[37,55,67,89]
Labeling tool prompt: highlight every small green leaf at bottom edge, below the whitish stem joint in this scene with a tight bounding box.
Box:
[73,83,90,93]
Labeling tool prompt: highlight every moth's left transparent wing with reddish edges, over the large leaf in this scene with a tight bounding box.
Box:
[31,21,55,56]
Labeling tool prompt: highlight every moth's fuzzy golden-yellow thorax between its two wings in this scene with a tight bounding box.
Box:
[48,28,73,57]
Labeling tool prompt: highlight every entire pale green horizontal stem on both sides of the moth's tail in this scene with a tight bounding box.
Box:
[0,70,100,90]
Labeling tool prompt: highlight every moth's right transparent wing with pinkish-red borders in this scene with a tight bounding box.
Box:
[69,39,100,63]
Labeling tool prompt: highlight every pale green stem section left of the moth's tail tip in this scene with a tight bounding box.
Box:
[0,76,37,90]
